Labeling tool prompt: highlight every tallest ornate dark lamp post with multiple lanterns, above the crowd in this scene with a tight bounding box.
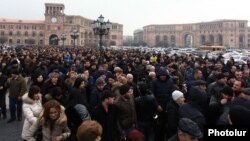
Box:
[92,15,111,64]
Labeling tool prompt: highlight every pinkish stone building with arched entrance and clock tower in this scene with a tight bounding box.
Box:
[0,3,123,46]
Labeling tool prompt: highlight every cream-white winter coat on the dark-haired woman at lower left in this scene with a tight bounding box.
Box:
[22,93,43,141]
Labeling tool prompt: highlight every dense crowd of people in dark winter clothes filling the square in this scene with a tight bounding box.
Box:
[0,47,250,141]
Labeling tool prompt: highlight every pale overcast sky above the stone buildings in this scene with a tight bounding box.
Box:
[0,0,250,35]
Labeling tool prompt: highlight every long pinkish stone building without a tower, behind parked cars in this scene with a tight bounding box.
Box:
[143,20,250,48]
